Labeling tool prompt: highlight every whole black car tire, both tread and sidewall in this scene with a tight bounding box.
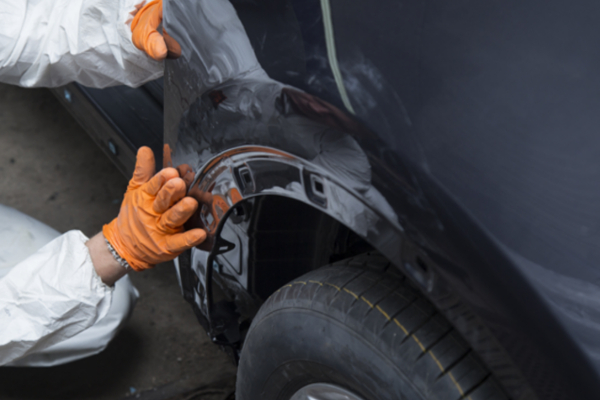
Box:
[236,253,508,400]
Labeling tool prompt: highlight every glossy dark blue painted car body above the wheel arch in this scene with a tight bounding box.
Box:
[165,0,600,399]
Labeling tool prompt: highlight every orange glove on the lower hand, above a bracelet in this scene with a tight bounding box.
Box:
[102,147,206,271]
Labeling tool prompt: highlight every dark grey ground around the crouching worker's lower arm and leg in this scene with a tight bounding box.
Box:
[0,85,235,400]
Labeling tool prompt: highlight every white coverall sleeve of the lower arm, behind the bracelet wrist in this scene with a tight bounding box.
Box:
[0,231,113,365]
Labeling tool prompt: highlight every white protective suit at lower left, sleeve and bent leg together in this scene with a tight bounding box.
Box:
[0,205,139,366]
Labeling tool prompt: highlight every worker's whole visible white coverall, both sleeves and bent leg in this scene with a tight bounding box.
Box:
[0,0,163,365]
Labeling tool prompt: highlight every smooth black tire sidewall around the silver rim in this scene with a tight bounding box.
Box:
[237,300,422,400]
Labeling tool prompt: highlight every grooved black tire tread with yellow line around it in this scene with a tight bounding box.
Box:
[244,253,508,400]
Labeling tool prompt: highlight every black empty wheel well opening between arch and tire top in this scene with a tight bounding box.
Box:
[248,196,373,299]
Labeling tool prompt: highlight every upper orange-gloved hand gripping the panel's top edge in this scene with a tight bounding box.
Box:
[131,0,181,61]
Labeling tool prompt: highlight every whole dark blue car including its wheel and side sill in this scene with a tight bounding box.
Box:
[50,0,600,400]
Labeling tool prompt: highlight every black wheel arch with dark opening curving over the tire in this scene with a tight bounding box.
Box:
[175,146,534,398]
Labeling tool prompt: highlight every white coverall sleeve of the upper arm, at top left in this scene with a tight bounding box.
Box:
[0,0,164,88]
